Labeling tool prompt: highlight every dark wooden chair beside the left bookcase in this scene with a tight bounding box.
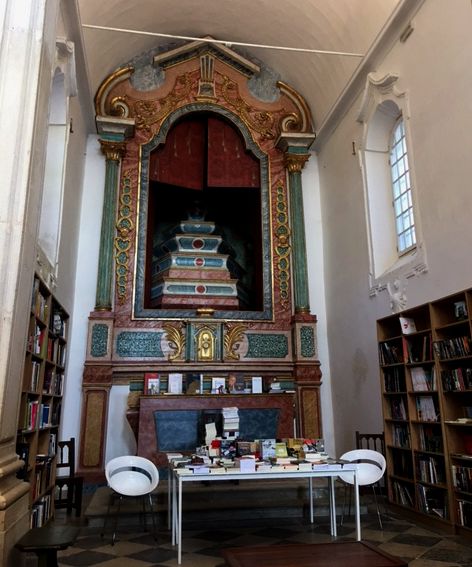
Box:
[54,437,84,517]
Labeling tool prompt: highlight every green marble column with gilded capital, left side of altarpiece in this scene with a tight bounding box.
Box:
[95,140,126,311]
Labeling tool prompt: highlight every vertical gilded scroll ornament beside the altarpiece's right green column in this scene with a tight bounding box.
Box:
[275,182,290,309]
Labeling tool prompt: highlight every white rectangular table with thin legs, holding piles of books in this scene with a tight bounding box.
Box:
[169,464,361,565]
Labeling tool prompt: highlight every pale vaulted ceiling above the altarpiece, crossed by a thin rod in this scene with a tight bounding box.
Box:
[78,0,401,128]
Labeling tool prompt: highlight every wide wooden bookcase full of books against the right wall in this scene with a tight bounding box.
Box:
[377,290,472,531]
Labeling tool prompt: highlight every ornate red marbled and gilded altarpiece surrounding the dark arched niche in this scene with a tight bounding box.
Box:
[80,40,321,475]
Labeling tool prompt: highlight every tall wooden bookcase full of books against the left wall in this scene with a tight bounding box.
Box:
[17,276,69,527]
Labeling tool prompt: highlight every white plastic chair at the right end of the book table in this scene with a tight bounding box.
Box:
[339,449,387,530]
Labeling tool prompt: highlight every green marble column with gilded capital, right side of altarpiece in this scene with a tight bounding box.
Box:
[285,151,310,313]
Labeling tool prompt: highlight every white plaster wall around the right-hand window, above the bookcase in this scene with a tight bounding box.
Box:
[319,0,472,453]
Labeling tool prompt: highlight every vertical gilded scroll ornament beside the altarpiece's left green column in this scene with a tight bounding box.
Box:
[115,171,134,305]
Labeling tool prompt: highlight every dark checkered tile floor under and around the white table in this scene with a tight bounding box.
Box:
[51,486,472,567]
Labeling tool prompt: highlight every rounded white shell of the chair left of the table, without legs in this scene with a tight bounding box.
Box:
[105,455,159,496]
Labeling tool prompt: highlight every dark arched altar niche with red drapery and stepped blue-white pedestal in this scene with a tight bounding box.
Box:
[134,106,272,320]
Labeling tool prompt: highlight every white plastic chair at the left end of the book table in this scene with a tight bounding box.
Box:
[102,455,159,545]
